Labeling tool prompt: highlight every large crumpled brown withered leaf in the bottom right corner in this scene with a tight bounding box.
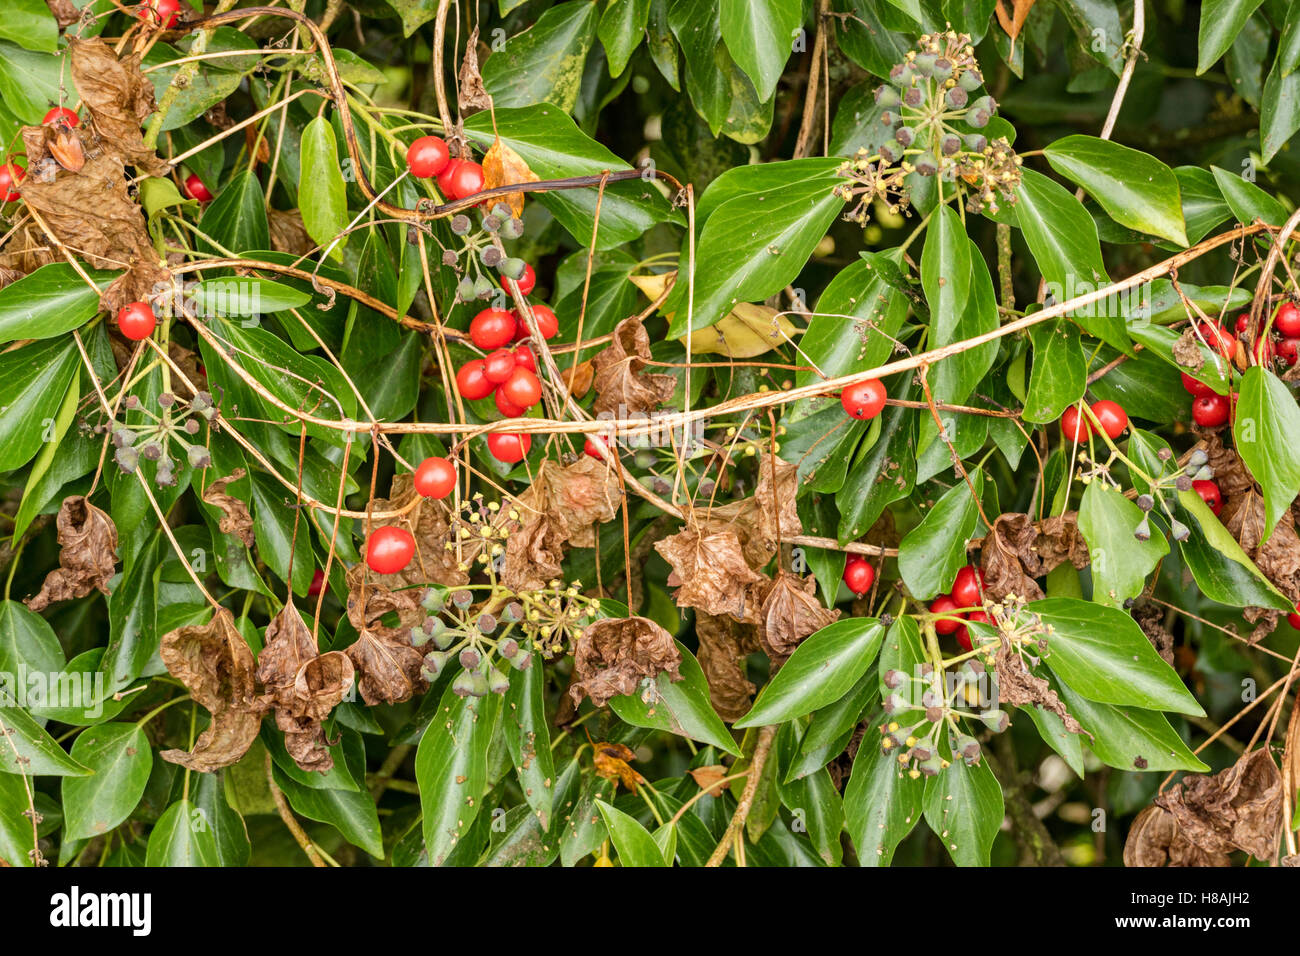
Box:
[1156,747,1282,860]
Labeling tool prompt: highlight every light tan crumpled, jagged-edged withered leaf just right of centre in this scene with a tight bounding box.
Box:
[654,527,766,620]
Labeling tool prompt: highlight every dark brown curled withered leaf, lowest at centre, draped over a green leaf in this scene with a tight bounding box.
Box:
[569,618,681,708]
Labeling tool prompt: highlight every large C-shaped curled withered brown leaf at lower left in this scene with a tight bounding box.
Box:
[159,607,268,774]
